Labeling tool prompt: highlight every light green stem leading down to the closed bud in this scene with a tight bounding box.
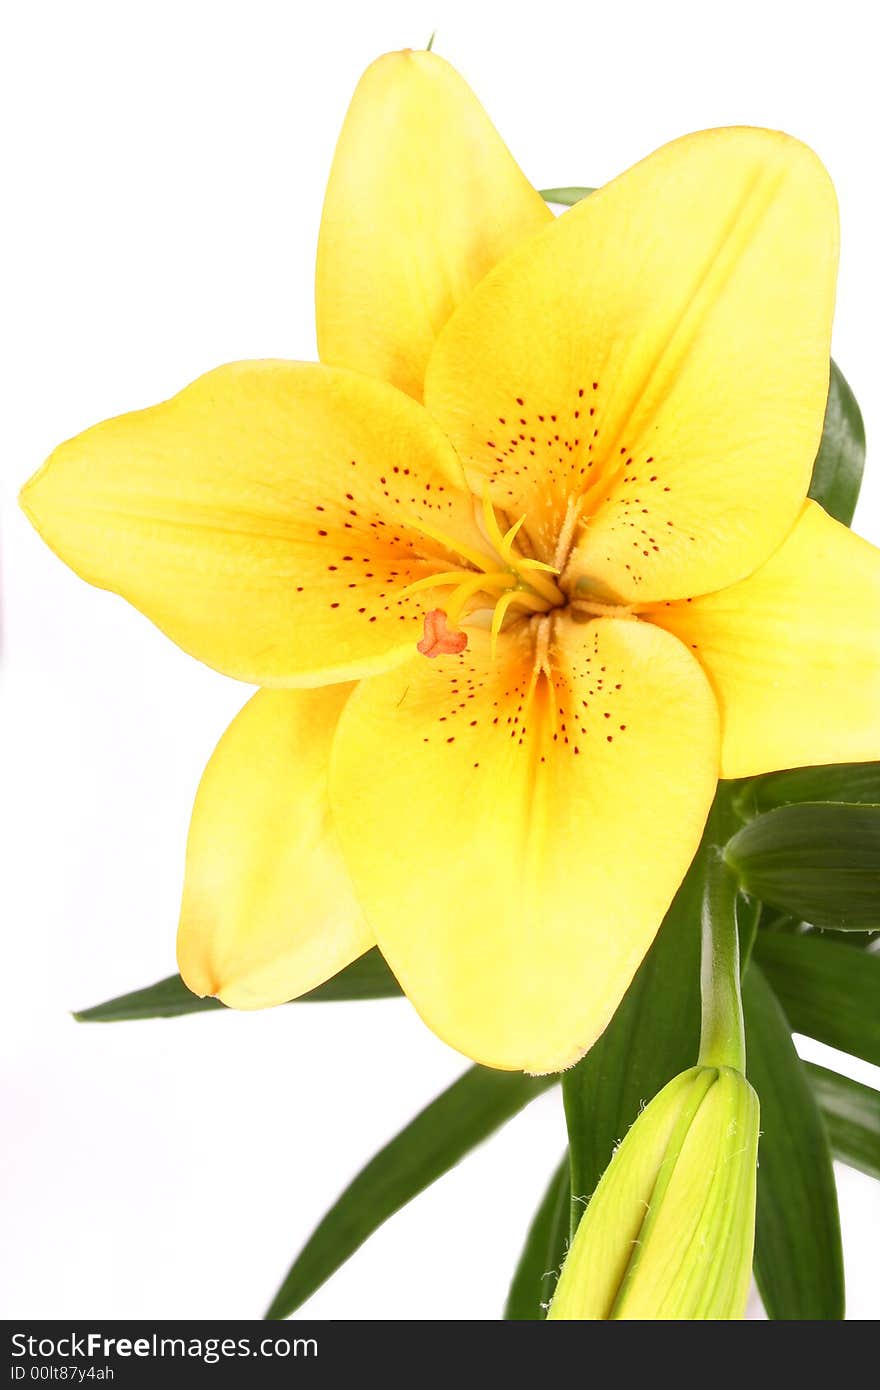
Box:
[699,849,745,1072]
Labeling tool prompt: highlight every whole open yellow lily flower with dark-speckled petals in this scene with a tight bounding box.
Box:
[22,53,880,1072]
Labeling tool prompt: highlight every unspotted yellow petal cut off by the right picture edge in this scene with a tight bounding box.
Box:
[648,502,880,777]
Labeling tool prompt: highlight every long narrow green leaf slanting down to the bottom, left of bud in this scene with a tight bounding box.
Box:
[266,1066,557,1318]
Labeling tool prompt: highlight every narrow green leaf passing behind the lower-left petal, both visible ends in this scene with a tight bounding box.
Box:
[74,947,402,1023]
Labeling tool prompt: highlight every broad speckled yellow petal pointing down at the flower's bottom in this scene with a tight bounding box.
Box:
[331,617,719,1073]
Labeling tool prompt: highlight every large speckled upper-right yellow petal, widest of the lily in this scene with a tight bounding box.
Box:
[425,129,837,592]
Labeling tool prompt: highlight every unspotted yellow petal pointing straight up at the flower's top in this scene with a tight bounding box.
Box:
[316,50,552,400]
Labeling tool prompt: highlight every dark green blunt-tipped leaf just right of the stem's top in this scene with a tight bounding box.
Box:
[724,801,880,931]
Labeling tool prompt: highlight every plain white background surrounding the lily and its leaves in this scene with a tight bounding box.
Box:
[0,0,880,1319]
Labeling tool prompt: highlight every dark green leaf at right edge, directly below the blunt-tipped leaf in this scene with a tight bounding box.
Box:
[755,931,880,1066]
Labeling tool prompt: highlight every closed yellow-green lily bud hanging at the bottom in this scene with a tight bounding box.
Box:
[548,1066,759,1321]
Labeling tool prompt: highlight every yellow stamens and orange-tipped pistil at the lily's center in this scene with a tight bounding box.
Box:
[405,488,566,656]
